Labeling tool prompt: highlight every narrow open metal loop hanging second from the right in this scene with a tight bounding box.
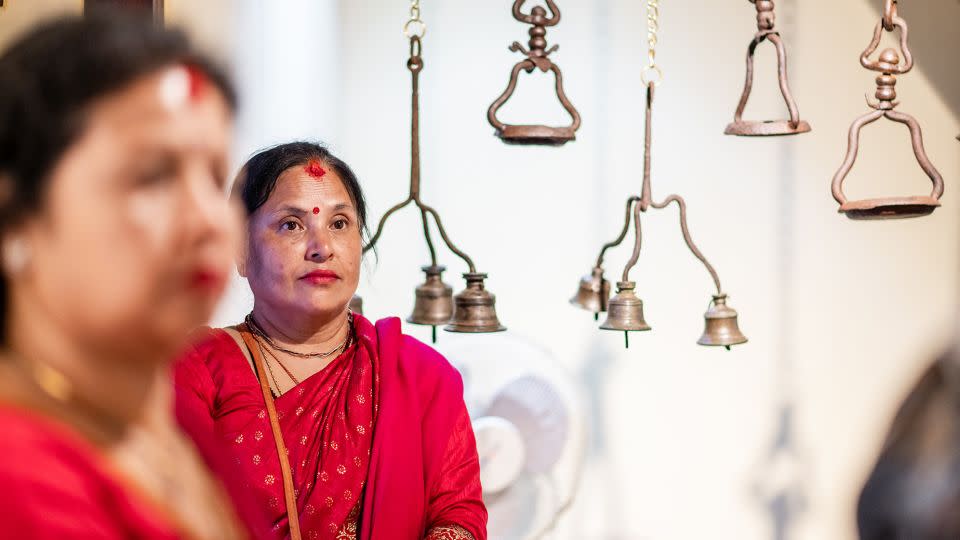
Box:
[724,30,810,136]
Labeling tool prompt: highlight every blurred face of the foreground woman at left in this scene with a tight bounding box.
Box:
[13,67,241,356]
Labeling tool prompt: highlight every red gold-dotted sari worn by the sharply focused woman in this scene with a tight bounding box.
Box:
[175,316,487,540]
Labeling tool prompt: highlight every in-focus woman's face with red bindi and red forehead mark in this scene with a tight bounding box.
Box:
[241,165,362,320]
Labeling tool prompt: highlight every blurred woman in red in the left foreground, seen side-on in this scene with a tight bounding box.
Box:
[0,9,247,540]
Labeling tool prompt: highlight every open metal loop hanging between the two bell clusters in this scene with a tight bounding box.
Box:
[487,58,580,146]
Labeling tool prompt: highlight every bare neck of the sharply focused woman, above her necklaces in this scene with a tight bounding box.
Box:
[252,302,350,352]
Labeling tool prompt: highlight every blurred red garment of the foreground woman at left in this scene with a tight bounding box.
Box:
[0,404,185,540]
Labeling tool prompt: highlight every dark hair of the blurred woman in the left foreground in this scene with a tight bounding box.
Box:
[0,9,236,338]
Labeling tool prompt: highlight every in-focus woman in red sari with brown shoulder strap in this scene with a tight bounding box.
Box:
[176,143,487,540]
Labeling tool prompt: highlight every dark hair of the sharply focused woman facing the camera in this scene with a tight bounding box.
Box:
[233,141,367,239]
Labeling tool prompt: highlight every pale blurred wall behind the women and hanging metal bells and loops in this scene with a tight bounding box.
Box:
[0,0,960,540]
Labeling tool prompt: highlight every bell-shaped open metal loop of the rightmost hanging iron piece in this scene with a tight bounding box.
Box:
[832,110,943,219]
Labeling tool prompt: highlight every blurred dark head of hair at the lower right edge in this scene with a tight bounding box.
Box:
[857,349,960,540]
